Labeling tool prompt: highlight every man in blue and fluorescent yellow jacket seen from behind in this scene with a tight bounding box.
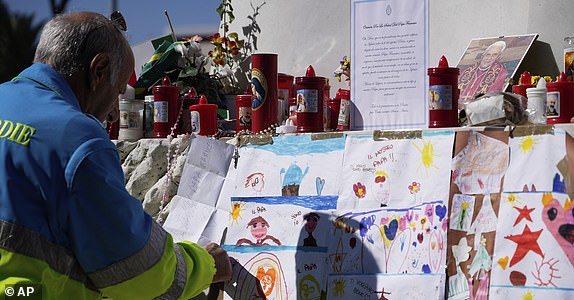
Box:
[0,12,231,299]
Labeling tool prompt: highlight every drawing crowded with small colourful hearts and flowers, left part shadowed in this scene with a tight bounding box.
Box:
[328,201,446,274]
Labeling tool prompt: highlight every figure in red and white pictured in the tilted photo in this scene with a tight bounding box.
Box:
[458,41,508,109]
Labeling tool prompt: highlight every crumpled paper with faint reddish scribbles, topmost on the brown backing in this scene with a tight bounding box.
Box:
[452,131,509,194]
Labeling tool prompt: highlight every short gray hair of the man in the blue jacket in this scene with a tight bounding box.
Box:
[34,13,129,83]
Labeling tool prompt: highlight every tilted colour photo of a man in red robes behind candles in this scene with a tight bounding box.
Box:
[457,34,538,109]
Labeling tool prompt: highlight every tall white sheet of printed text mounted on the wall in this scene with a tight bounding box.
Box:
[351,0,428,130]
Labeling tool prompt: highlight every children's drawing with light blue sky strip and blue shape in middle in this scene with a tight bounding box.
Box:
[231,135,345,198]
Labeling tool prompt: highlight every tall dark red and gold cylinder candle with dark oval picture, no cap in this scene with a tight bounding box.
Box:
[251,53,277,132]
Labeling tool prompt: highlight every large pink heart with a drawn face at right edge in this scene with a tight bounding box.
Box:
[542,193,574,266]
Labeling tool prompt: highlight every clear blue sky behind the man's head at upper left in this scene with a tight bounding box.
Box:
[4,0,220,45]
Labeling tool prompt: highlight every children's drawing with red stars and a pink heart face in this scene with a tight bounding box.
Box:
[490,192,574,299]
